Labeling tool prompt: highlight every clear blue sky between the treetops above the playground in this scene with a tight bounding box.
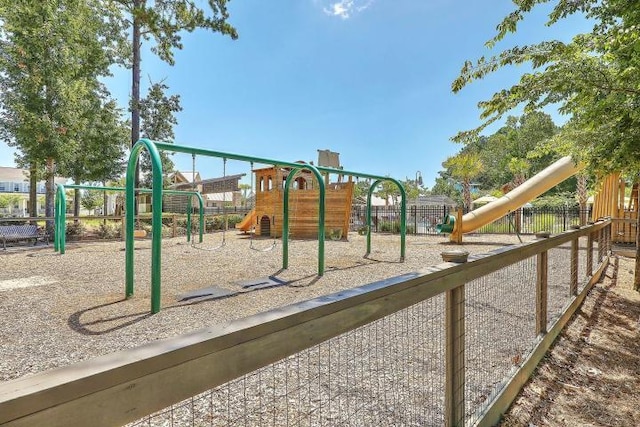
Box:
[0,0,589,187]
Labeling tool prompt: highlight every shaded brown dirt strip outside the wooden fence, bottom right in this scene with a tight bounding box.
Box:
[499,257,640,427]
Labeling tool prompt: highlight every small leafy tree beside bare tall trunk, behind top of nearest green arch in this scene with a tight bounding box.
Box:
[140,82,182,187]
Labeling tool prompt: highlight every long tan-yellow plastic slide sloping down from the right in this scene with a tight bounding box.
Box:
[453,156,582,235]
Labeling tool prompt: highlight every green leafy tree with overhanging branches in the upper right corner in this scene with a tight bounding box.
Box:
[452,0,640,289]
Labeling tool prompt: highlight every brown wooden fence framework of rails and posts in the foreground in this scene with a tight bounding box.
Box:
[0,221,611,426]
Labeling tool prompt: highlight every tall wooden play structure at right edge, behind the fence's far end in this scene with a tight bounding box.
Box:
[592,173,638,243]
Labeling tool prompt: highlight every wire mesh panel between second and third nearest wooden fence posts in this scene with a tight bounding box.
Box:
[547,242,572,328]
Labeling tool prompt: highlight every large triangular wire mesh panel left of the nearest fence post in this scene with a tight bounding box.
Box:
[131,295,445,426]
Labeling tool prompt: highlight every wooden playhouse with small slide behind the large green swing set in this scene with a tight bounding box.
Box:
[236,162,354,240]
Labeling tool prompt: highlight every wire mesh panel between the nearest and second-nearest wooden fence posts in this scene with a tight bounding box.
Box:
[465,257,536,421]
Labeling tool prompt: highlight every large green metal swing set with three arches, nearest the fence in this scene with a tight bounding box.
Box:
[125,139,406,313]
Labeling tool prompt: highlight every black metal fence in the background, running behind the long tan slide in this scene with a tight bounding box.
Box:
[350,205,591,235]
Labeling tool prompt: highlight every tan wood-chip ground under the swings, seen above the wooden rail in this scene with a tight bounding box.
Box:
[0,232,534,381]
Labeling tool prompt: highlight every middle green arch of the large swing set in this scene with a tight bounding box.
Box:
[282,165,326,276]
